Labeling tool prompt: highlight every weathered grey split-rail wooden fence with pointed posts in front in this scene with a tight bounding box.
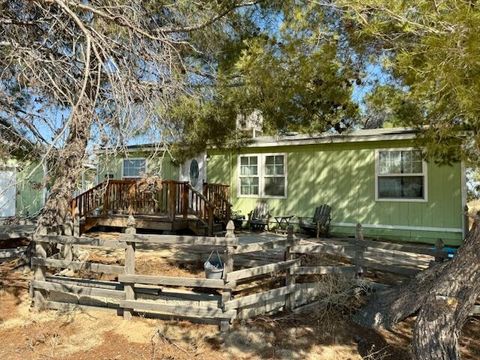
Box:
[31,218,376,329]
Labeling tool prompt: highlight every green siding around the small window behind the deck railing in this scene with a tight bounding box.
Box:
[98,152,179,181]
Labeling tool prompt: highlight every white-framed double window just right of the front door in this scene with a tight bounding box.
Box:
[238,154,287,198]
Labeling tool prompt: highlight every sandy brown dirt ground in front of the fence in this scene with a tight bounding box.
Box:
[0,252,480,360]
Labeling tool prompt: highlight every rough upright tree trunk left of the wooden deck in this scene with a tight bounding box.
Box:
[36,107,93,234]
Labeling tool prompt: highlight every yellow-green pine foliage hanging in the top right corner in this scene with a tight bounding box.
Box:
[337,0,480,164]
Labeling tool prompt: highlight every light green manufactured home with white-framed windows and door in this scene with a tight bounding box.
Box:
[98,128,466,245]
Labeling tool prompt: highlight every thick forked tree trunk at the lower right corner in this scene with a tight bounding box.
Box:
[354,219,480,360]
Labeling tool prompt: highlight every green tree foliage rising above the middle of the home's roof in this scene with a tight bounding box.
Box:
[169,2,358,156]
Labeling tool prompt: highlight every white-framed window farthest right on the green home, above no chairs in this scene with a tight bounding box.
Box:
[375,149,427,201]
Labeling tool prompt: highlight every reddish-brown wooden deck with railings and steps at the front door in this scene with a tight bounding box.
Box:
[70,180,232,235]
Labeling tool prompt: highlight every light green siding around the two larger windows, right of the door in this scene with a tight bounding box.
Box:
[207,141,463,245]
